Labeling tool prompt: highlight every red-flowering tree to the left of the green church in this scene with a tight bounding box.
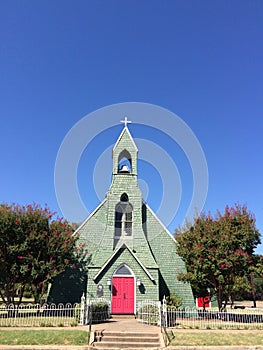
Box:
[0,204,88,303]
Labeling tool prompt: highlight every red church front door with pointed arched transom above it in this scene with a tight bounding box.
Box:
[111,264,135,314]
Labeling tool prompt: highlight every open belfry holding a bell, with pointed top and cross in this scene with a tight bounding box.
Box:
[112,117,138,177]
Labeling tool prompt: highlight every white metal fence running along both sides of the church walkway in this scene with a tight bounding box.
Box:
[0,298,263,332]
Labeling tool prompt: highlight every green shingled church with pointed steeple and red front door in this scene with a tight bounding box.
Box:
[48,118,195,314]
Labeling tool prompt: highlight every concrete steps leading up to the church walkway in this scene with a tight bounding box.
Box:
[93,331,163,350]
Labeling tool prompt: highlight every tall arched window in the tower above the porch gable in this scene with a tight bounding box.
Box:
[115,197,133,238]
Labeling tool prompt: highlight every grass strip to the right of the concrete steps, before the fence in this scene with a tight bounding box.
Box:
[170,330,263,347]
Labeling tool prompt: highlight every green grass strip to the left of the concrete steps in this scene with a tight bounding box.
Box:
[0,330,88,345]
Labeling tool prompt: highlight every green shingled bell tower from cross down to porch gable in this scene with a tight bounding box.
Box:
[107,117,151,252]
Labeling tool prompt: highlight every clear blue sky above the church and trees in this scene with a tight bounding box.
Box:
[0,0,263,254]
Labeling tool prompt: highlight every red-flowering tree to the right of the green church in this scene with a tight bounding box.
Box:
[176,205,260,309]
